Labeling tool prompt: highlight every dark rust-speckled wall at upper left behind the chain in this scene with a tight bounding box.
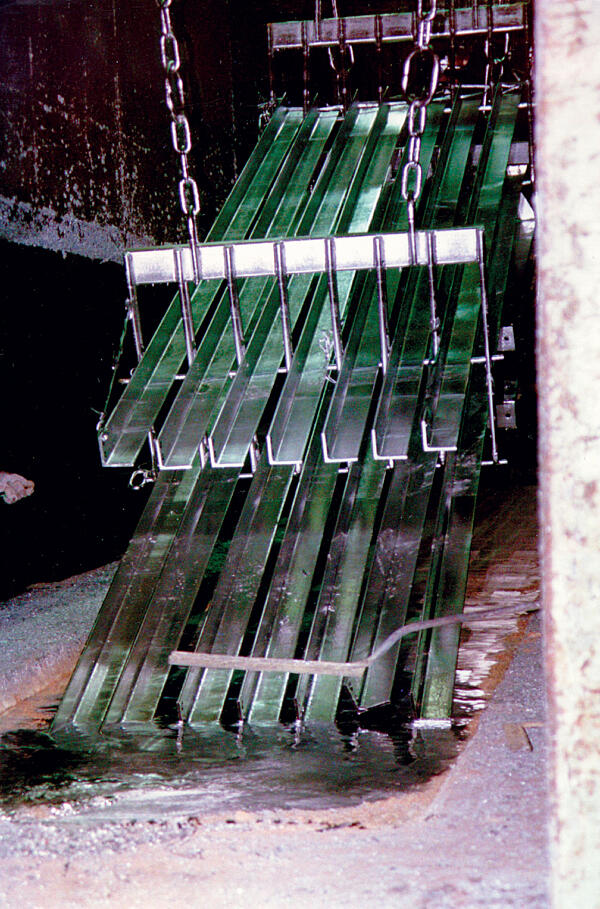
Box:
[0,0,235,259]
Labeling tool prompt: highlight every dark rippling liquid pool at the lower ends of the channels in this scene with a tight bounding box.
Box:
[0,692,463,823]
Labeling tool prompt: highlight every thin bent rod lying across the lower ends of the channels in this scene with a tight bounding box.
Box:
[169,603,540,677]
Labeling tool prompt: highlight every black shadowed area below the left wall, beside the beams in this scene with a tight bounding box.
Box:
[0,243,146,599]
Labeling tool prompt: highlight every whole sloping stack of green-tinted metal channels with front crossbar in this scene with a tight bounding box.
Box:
[54,91,523,731]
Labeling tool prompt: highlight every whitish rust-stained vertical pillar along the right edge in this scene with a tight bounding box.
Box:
[535,0,600,909]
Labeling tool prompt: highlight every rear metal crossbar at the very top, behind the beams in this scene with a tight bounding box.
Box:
[268,3,526,51]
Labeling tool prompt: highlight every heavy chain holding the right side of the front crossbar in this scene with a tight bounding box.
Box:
[401,0,440,262]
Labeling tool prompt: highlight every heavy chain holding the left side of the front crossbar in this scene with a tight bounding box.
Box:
[157,0,200,282]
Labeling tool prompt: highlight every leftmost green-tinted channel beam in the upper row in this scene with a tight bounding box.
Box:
[100,109,302,467]
